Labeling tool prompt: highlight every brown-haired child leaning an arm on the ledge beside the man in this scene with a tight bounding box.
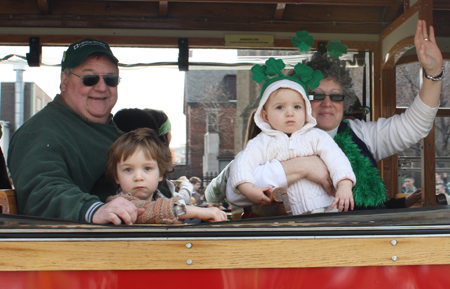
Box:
[106,128,226,224]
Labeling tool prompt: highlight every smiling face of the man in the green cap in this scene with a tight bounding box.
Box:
[61,55,118,123]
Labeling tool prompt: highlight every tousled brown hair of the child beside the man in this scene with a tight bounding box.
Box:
[106,128,174,181]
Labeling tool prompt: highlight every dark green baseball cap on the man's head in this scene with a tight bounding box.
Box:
[61,38,119,71]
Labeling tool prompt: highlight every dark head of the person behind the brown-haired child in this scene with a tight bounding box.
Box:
[113,108,169,146]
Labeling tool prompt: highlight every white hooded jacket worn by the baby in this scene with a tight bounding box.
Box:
[227,79,356,215]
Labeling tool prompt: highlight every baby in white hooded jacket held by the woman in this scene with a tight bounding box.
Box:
[227,61,356,215]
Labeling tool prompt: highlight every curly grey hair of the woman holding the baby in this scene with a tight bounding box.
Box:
[305,52,357,112]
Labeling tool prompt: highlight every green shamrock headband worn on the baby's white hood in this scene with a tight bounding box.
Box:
[251,57,323,98]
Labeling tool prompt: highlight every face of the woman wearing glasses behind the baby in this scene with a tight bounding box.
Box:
[311,78,344,131]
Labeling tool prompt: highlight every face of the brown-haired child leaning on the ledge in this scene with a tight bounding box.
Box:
[116,149,163,200]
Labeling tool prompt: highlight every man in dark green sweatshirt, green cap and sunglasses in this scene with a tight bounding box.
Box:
[8,38,142,225]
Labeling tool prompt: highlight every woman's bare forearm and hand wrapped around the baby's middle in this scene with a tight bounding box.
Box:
[281,156,336,196]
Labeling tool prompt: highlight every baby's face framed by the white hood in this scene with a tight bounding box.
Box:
[261,88,306,135]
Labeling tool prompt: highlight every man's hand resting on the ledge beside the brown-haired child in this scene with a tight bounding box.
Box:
[92,198,145,225]
